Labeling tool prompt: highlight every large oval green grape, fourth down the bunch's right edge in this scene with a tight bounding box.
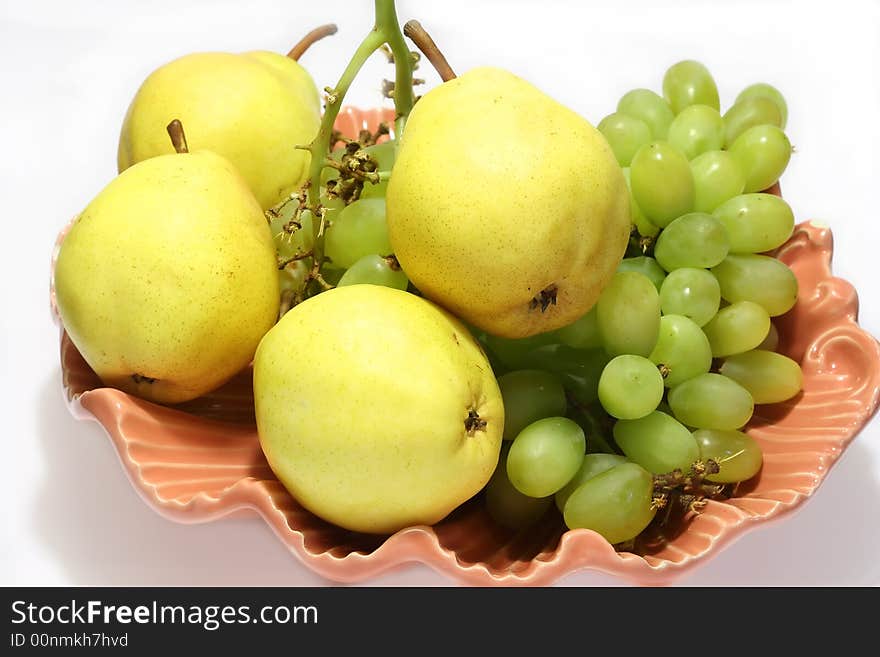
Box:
[712,254,798,317]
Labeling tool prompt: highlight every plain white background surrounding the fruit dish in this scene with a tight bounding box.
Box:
[0,0,880,586]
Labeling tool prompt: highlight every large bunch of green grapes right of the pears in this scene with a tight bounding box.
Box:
[480,61,802,544]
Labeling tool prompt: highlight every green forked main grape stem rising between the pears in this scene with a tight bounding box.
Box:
[301,0,415,302]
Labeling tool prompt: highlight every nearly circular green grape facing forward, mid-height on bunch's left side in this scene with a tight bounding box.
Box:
[599,356,660,420]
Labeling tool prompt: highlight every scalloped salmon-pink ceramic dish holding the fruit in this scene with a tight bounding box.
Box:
[52,109,880,585]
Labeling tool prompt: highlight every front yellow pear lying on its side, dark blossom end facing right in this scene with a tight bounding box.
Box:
[254,284,504,534]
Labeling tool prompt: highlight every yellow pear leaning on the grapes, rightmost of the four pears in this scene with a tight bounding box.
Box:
[387,67,630,338]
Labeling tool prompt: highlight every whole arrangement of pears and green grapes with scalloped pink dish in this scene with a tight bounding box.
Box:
[53,0,880,583]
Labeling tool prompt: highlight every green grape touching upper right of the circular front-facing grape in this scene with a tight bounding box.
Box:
[648,315,712,384]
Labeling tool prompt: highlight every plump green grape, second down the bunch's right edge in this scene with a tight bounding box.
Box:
[728,125,791,194]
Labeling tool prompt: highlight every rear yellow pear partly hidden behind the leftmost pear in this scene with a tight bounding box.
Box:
[118,51,321,209]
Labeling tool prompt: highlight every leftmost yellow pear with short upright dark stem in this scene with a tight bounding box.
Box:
[55,151,279,403]
